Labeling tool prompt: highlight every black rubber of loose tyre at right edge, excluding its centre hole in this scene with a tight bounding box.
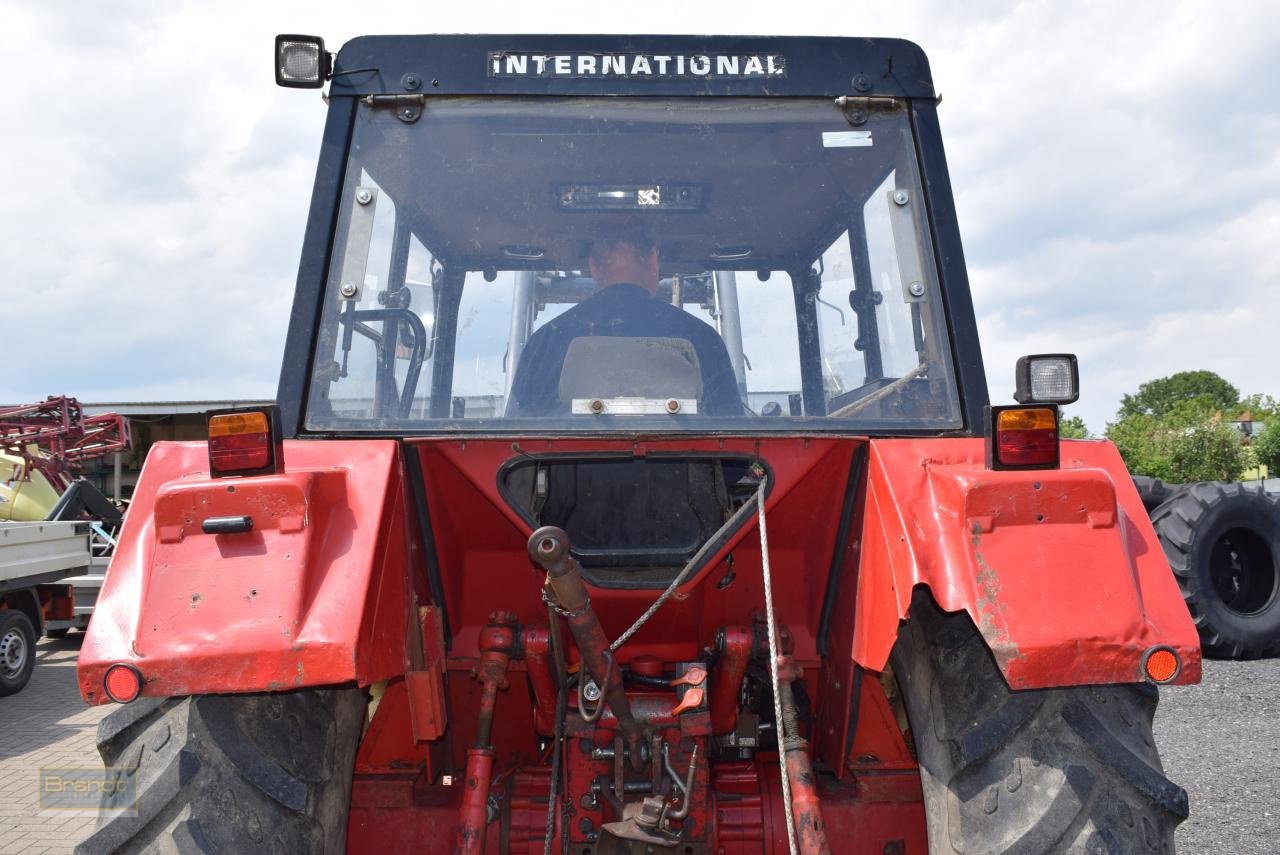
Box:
[1151,481,1280,659]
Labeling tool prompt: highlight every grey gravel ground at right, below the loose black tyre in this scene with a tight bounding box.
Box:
[1156,659,1280,855]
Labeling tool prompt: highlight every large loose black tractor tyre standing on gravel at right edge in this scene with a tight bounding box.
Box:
[1151,481,1280,659]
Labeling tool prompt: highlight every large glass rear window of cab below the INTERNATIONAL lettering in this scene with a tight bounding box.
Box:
[307,97,960,431]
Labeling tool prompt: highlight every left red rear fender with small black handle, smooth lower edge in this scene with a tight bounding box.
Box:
[78,440,412,704]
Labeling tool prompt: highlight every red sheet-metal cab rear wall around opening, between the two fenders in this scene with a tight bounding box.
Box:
[407,436,861,666]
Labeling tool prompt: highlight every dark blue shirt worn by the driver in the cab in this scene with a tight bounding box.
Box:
[507,283,744,416]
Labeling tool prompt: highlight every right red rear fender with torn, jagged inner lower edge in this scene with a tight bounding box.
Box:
[854,439,1201,689]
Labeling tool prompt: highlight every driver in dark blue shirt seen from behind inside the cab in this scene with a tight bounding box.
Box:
[507,229,744,416]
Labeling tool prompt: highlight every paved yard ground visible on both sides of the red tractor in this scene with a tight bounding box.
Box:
[0,632,1280,855]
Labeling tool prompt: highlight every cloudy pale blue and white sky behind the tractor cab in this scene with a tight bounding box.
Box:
[0,0,1280,430]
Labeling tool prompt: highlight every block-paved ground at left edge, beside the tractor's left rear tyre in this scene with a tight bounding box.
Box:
[0,632,110,855]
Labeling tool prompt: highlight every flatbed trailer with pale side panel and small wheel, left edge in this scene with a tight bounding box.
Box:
[0,521,92,695]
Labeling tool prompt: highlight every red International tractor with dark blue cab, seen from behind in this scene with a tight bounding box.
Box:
[79,36,1201,855]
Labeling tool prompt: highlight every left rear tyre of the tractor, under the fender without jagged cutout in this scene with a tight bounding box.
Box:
[76,686,365,852]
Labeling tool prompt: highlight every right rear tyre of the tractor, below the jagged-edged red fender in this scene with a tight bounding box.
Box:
[891,591,1187,855]
